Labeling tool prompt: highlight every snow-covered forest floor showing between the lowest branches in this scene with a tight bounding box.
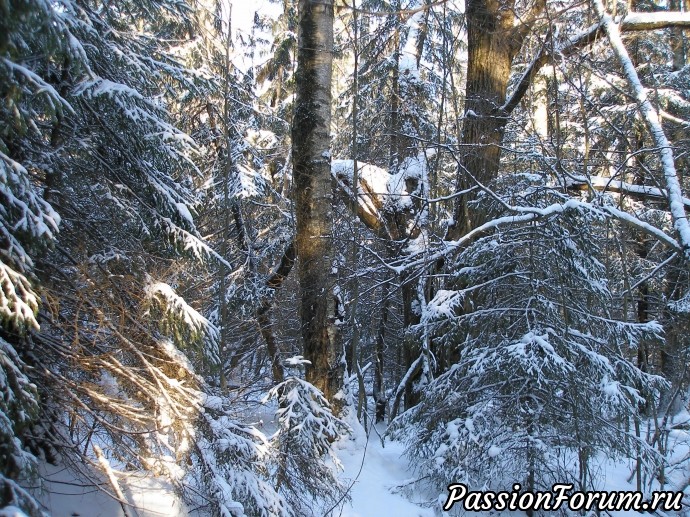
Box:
[35,413,690,517]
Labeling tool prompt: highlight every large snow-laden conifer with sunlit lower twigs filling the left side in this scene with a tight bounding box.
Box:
[0,0,306,515]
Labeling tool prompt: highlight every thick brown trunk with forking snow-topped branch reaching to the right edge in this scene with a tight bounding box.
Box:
[447,0,690,240]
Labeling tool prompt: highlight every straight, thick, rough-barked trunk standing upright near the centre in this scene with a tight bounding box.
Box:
[292,0,343,403]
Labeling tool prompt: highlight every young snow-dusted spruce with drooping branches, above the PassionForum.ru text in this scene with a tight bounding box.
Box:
[393,175,665,500]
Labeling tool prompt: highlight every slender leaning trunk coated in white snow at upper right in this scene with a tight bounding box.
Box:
[593,0,690,261]
